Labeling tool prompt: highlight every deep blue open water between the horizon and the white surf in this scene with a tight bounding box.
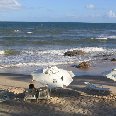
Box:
[0,22,116,48]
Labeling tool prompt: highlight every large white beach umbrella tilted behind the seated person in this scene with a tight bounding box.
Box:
[31,66,74,88]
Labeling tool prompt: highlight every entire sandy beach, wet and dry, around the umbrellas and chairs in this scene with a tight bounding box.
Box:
[0,49,116,116]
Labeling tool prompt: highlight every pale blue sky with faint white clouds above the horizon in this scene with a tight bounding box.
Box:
[0,0,116,23]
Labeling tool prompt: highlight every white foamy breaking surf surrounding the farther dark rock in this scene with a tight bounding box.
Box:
[0,47,116,68]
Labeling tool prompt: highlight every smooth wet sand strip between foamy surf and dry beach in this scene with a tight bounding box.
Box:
[0,61,116,76]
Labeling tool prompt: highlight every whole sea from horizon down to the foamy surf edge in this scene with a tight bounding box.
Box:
[0,22,116,74]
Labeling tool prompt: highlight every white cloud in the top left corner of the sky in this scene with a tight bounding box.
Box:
[0,0,21,10]
